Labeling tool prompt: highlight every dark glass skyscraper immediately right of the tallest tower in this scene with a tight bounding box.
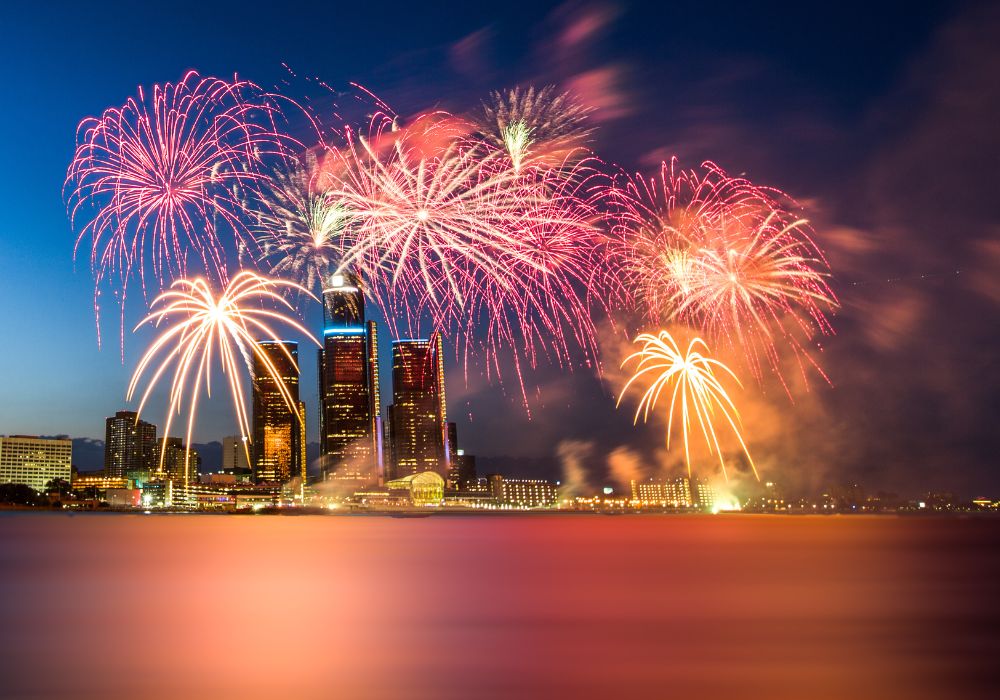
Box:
[389,333,449,479]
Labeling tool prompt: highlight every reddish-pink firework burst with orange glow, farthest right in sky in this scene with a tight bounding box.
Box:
[612,160,837,388]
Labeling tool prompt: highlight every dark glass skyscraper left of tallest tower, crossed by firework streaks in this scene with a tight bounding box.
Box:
[252,340,306,483]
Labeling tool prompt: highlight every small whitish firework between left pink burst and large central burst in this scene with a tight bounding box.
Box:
[255,153,348,290]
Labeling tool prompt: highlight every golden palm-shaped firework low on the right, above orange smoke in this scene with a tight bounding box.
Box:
[618,331,757,479]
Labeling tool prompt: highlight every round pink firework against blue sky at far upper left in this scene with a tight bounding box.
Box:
[64,71,296,342]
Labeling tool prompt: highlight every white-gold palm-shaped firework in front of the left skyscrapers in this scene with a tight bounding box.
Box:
[126,271,318,480]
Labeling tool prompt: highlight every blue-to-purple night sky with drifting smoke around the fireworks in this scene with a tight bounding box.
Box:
[0,1,1000,496]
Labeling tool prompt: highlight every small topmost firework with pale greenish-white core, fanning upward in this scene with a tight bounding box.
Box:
[479,85,593,171]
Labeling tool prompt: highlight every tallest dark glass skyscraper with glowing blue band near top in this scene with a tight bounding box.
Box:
[319,274,382,481]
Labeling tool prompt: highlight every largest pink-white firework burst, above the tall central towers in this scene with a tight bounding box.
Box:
[332,109,601,402]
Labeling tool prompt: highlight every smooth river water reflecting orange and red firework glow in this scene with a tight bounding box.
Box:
[0,513,1000,700]
